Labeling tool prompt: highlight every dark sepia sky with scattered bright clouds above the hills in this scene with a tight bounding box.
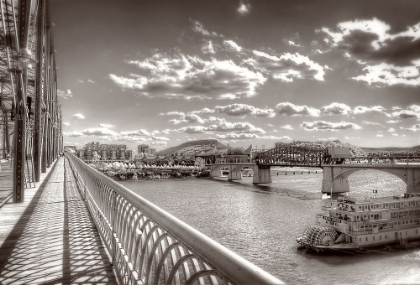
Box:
[50,0,420,150]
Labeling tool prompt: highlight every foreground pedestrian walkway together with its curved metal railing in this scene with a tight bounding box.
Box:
[0,155,283,285]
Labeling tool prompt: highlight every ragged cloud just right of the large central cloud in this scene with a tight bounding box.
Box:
[244,50,329,82]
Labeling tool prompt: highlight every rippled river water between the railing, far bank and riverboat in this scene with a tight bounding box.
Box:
[122,169,420,284]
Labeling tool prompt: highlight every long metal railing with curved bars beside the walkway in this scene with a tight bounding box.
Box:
[67,154,283,285]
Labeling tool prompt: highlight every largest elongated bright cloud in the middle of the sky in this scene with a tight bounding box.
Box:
[109,53,266,99]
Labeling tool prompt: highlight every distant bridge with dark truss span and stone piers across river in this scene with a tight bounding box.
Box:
[206,146,420,193]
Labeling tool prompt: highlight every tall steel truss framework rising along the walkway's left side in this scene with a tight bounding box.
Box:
[0,0,63,202]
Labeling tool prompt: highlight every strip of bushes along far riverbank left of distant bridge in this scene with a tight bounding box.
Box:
[90,165,210,181]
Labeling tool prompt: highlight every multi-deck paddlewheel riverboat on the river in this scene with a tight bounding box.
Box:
[296,193,420,251]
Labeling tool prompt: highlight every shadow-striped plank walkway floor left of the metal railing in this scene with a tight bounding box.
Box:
[0,158,117,284]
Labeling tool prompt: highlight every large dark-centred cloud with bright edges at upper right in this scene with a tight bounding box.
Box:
[321,18,420,86]
